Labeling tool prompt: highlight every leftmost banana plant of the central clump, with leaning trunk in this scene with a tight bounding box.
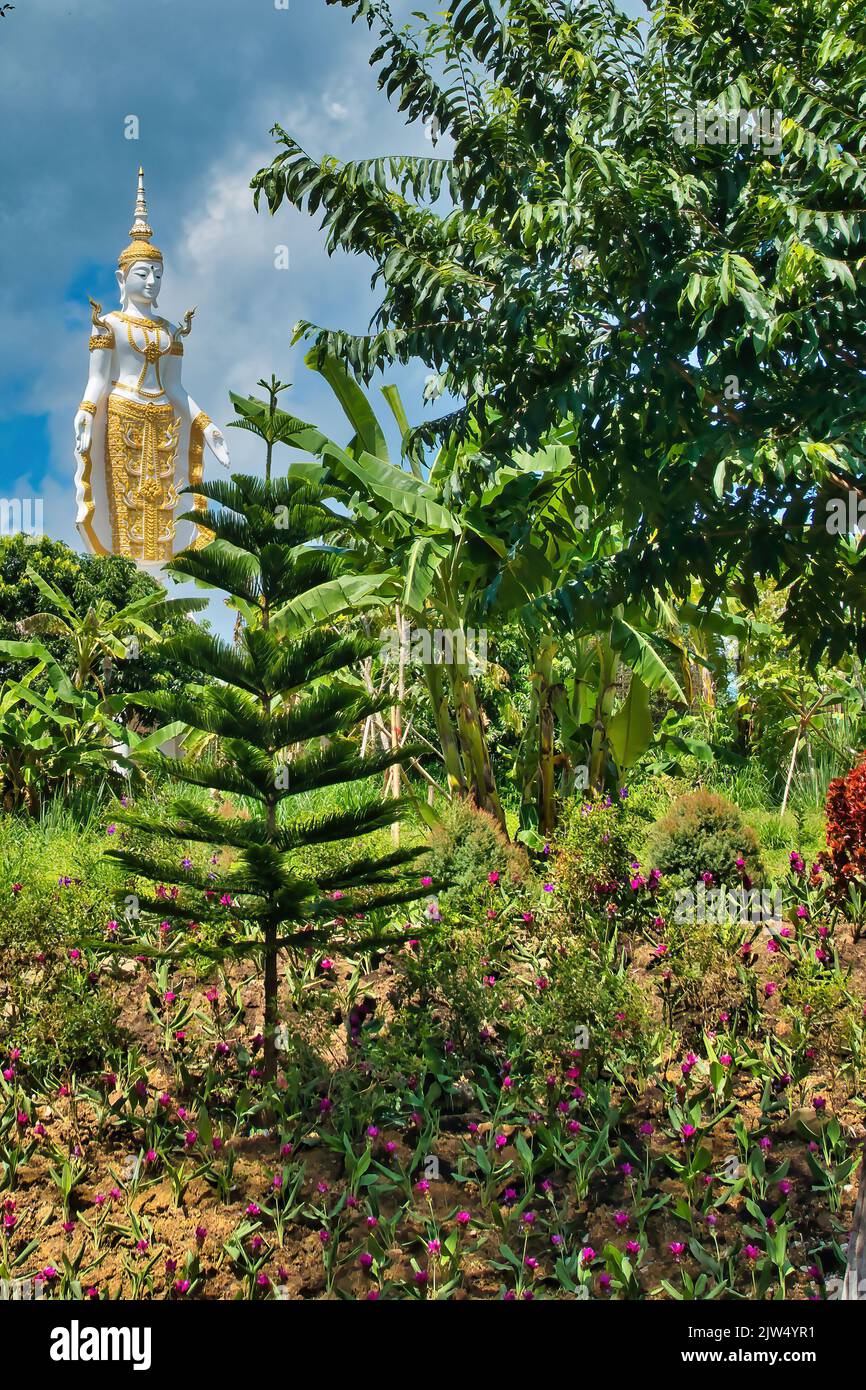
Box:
[232,354,522,828]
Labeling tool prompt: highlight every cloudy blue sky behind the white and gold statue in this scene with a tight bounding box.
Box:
[0,0,637,594]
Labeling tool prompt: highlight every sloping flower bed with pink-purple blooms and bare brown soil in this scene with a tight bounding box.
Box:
[0,780,866,1298]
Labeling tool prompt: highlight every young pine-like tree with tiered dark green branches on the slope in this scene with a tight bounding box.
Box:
[113,379,421,1084]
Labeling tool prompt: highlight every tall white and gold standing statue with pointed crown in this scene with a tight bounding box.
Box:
[75,170,229,571]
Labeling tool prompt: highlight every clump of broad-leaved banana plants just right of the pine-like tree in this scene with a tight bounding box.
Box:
[264,354,733,844]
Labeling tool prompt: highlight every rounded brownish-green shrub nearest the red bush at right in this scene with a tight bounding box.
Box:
[648,791,765,887]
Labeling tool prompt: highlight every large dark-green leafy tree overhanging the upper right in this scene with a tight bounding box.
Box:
[253,0,866,657]
